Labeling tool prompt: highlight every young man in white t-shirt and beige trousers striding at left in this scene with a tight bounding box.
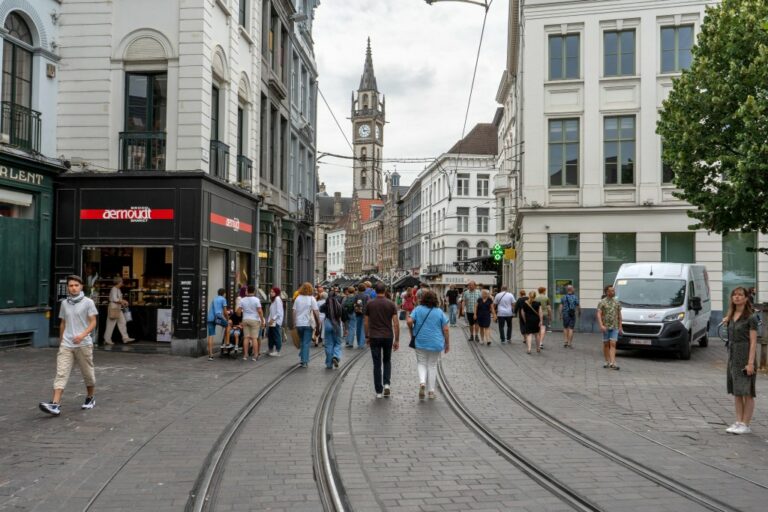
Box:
[40,276,99,416]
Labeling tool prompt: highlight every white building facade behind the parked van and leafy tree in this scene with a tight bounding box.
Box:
[511,0,768,330]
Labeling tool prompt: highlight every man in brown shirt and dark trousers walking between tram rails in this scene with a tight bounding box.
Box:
[365,282,400,398]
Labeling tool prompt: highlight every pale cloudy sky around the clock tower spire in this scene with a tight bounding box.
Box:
[313,0,508,195]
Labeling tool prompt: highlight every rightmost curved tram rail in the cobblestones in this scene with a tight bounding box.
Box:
[464,332,738,512]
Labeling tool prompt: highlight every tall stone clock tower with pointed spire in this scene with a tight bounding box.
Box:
[351,37,385,199]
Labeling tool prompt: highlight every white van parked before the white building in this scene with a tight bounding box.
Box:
[614,263,712,359]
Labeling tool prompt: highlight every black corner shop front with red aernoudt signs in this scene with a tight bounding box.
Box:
[54,172,257,355]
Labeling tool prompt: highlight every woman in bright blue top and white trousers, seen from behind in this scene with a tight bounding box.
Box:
[408,291,450,399]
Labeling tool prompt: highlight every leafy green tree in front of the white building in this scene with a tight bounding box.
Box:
[656,0,768,243]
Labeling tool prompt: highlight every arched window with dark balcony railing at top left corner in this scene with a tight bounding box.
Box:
[2,12,35,149]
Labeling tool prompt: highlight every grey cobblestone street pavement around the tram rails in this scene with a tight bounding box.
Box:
[0,320,768,511]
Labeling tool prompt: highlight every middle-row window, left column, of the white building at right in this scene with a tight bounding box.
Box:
[549,119,579,187]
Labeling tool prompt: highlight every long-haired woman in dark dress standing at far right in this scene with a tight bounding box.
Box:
[723,287,758,434]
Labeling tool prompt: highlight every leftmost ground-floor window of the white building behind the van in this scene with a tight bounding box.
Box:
[547,234,580,328]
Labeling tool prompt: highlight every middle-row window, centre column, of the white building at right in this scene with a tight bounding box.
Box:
[603,116,635,185]
